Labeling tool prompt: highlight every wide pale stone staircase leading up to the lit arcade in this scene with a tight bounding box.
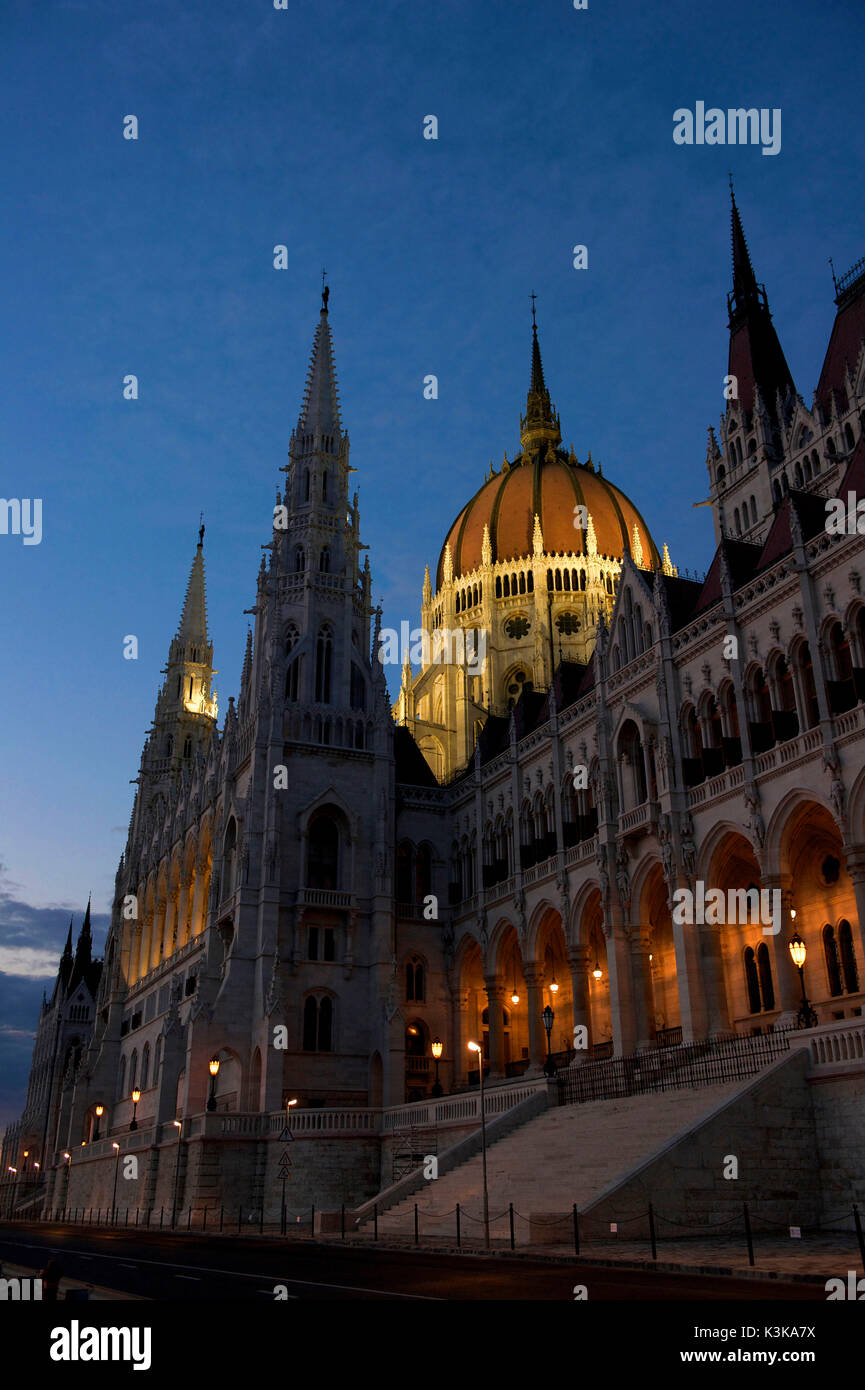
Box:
[363,1081,743,1241]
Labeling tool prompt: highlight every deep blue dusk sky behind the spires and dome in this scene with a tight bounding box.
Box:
[0,0,865,1117]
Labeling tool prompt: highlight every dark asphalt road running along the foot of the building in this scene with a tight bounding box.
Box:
[0,1222,826,1304]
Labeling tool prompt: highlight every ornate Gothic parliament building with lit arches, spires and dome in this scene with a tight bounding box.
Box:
[6,193,865,1207]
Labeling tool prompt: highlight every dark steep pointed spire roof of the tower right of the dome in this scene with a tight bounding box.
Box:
[727,183,795,430]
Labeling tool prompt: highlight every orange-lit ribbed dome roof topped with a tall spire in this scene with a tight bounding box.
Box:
[437,318,661,588]
